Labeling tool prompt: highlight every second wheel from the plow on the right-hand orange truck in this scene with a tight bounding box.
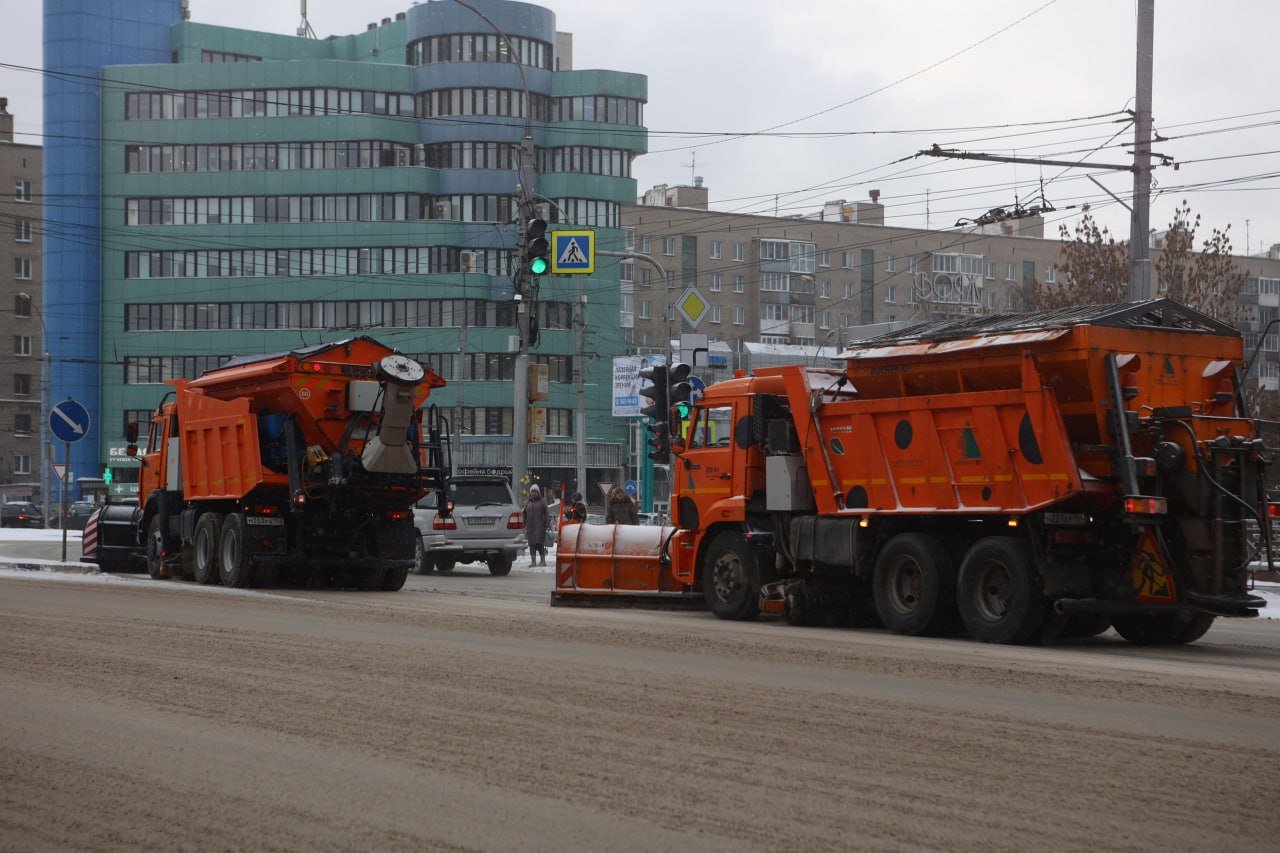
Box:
[872,533,957,637]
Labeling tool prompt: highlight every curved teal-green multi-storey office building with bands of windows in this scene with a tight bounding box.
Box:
[46,0,646,499]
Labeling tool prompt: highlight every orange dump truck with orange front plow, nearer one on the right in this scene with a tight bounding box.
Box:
[553,300,1272,644]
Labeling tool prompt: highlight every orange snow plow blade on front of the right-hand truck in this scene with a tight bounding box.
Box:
[552,524,703,607]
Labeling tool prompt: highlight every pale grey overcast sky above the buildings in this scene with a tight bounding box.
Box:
[0,0,1280,254]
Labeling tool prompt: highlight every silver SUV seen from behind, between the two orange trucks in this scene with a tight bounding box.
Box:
[424,474,527,575]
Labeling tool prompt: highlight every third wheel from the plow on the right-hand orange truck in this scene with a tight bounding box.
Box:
[956,537,1048,644]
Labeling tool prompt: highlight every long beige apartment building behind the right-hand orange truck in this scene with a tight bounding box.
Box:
[622,184,1280,387]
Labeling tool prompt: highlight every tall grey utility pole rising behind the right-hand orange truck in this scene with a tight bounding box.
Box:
[1129,0,1156,300]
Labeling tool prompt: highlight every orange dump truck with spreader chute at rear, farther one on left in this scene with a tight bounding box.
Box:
[86,337,448,590]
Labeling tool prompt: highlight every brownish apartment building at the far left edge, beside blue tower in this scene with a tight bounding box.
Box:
[0,97,44,501]
